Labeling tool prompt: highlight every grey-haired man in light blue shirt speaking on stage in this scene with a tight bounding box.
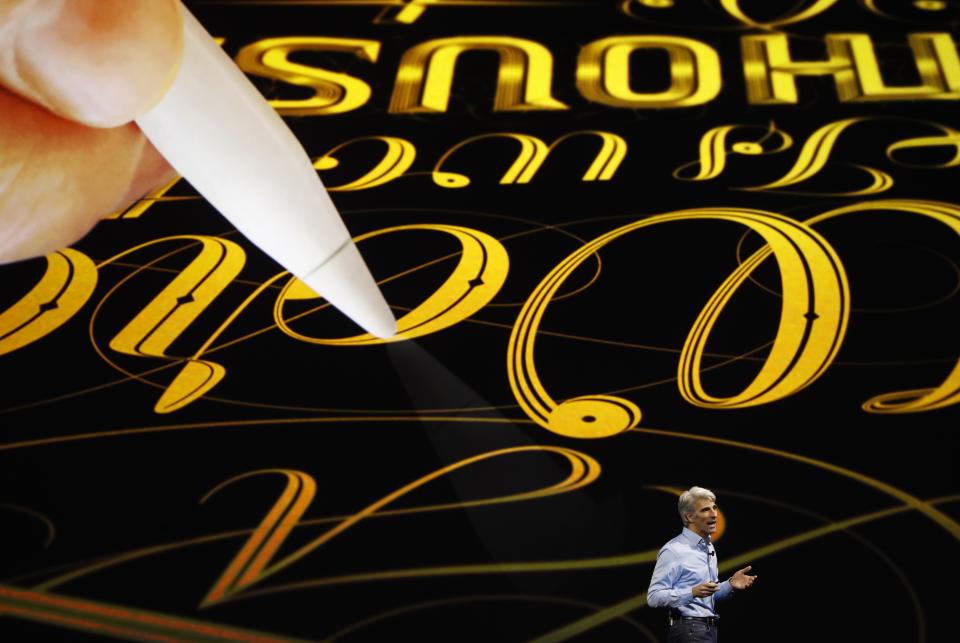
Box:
[647,487,757,643]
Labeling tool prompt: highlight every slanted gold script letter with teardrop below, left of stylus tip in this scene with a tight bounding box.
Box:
[104,235,246,413]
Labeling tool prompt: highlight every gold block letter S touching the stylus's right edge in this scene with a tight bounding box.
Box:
[236,36,380,116]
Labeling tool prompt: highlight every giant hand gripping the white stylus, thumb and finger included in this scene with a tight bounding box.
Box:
[0,0,183,263]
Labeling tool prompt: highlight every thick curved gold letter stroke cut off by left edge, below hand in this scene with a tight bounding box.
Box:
[0,248,97,355]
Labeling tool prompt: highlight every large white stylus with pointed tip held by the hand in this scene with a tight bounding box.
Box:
[136,5,397,338]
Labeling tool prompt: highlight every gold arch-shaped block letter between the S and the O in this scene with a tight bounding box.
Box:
[390,36,567,114]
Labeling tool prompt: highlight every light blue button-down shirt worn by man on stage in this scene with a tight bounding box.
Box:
[647,527,734,616]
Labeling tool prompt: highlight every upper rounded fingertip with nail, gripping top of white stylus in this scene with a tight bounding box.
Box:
[0,0,183,127]
